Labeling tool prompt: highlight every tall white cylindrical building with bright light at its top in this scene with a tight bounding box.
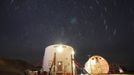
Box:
[42,44,75,75]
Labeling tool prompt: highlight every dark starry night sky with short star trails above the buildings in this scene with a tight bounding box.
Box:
[0,0,134,69]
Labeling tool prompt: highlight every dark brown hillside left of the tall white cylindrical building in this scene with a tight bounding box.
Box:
[0,58,34,75]
